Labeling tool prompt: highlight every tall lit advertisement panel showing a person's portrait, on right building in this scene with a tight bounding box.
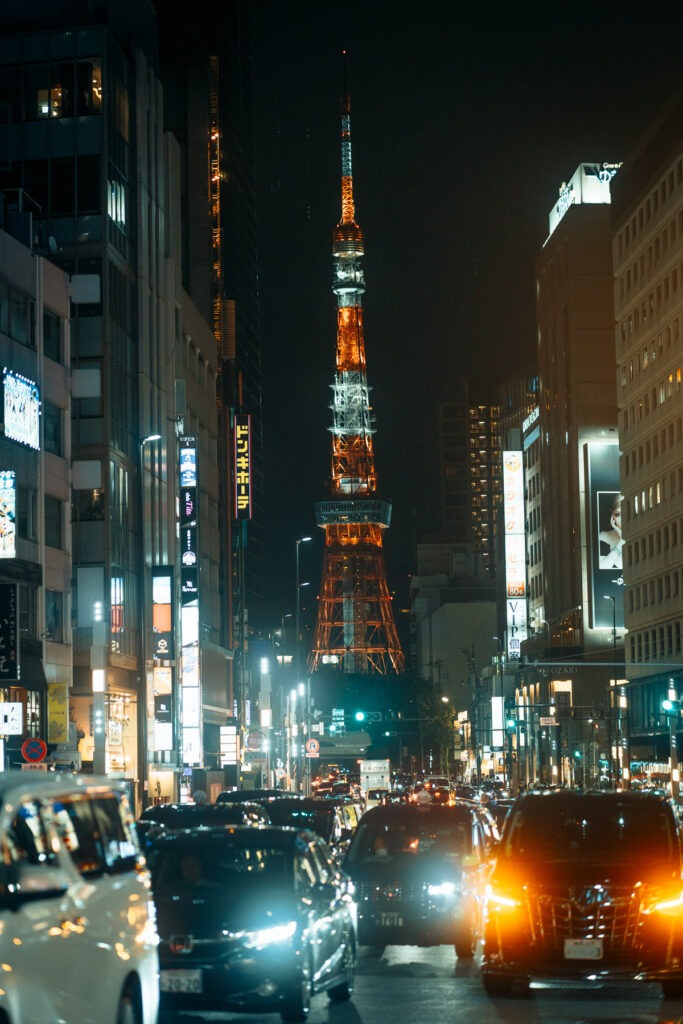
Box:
[586,442,624,629]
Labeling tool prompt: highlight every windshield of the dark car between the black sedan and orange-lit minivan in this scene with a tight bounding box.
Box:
[348,822,472,864]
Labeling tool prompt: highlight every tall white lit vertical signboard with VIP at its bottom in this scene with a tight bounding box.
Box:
[503,452,526,659]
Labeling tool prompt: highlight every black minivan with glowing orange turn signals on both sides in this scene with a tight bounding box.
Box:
[481,791,683,996]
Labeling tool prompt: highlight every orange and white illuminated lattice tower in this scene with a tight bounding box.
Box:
[310,88,403,675]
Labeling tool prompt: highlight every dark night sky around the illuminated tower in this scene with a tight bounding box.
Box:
[252,0,683,627]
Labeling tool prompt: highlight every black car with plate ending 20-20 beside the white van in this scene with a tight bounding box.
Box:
[146,825,356,1022]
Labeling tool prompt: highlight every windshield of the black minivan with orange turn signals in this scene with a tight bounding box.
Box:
[502,799,676,865]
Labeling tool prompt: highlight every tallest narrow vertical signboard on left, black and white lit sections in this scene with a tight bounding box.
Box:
[178,437,203,767]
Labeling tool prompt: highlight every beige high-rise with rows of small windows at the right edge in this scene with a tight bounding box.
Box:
[612,96,683,761]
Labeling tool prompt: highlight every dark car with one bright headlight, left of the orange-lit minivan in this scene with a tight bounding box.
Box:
[343,804,490,958]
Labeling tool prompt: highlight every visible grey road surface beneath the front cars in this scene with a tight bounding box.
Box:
[167,946,683,1024]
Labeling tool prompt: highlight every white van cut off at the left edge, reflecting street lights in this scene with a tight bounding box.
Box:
[0,771,159,1024]
